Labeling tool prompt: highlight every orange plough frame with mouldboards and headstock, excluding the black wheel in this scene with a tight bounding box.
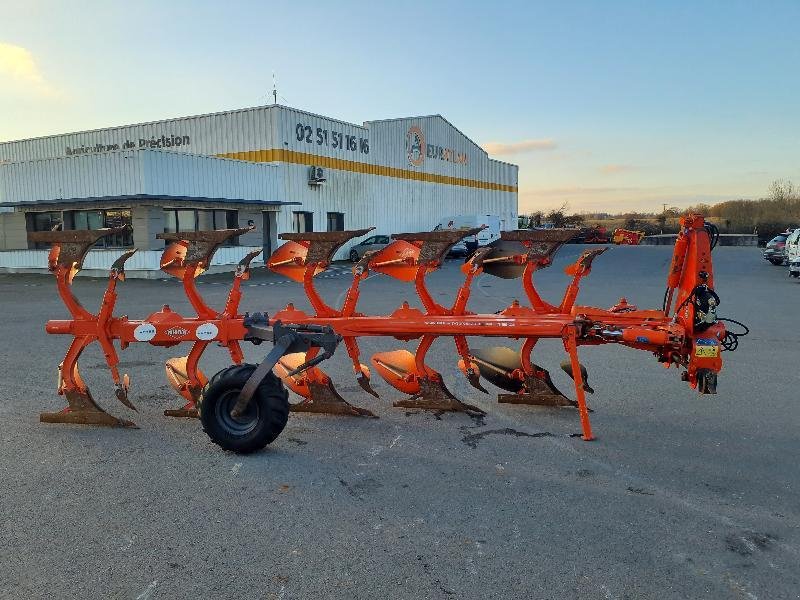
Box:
[36,215,725,440]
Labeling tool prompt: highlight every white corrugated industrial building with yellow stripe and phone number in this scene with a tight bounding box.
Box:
[0,105,518,276]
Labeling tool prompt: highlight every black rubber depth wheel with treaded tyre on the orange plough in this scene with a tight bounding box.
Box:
[197,364,289,454]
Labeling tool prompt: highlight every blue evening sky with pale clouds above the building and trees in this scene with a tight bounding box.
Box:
[0,0,800,213]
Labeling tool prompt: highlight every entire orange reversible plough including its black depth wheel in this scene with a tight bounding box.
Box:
[31,215,737,452]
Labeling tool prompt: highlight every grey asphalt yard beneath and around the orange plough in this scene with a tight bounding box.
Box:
[0,246,800,600]
